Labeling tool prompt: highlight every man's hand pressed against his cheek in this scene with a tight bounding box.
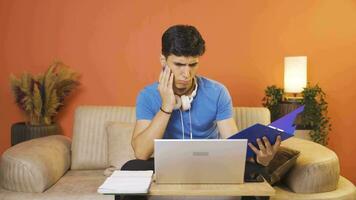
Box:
[158,67,176,112]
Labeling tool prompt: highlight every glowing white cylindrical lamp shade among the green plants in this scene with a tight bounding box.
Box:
[284,56,307,93]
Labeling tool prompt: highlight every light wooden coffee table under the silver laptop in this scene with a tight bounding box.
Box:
[115,181,275,200]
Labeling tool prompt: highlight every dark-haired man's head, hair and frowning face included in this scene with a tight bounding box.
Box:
[160,25,205,94]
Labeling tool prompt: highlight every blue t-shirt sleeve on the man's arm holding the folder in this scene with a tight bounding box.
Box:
[216,86,232,121]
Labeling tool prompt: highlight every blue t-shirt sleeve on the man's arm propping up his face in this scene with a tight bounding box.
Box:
[136,90,155,120]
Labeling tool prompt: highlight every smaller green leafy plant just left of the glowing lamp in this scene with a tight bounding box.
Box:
[262,85,283,121]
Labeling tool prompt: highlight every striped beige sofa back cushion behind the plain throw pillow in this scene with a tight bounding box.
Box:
[71,106,136,170]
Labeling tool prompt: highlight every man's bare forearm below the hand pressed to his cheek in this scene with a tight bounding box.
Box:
[132,111,171,160]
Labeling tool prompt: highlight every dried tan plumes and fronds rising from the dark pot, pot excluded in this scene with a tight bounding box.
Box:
[10,61,79,125]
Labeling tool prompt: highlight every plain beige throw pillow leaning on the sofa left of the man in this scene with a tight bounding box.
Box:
[106,122,135,175]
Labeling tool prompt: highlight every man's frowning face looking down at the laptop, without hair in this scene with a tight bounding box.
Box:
[166,55,199,93]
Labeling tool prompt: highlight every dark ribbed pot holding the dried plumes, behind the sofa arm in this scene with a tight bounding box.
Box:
[11,122,61,146]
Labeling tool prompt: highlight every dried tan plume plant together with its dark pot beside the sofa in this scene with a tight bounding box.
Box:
[10,61,79,145]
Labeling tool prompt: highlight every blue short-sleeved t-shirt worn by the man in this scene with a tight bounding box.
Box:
[136,76,232,139]
